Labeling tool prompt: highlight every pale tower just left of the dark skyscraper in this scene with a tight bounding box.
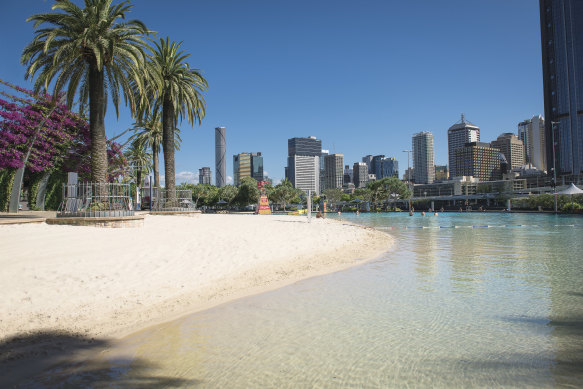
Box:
[518,115,547,171]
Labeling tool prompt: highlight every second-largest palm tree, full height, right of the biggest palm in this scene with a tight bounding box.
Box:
[151,38,208,196]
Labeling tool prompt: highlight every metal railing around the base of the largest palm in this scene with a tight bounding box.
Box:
[57,182,134,217]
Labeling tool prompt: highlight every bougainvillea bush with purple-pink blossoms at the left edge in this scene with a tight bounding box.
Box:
[0,80,127,210]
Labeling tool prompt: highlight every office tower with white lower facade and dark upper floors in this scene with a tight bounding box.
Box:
[287,136,322,194]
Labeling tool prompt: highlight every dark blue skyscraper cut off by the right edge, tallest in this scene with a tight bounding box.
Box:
[539,0,583,175]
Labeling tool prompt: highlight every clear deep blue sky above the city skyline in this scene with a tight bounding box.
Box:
[0,0,544,183]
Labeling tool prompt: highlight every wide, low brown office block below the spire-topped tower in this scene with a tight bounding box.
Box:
[455,142,502,181]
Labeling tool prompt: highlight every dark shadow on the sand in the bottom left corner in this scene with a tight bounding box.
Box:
[0,331,201,388]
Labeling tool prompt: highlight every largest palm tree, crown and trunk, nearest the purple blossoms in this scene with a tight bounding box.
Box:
[21,0,150,182]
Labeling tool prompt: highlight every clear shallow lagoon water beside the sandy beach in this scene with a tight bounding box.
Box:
[31,213,583,388]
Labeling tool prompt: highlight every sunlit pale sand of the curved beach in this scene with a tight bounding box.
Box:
[0,215,392,339]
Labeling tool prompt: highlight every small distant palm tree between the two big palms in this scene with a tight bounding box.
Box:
[130,110,182,188]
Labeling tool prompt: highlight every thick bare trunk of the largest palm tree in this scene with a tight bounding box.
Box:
[89,63,107,183]
